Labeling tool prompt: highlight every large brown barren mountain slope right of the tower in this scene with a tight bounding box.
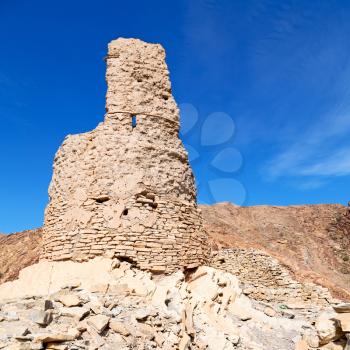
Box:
[201,203,350,299]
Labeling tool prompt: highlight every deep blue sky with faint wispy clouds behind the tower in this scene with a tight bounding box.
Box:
[0,0,350,233]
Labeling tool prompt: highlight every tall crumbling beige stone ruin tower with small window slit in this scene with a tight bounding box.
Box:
[41,38,209,272]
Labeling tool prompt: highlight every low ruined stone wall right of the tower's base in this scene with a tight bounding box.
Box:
[211,248,333,305]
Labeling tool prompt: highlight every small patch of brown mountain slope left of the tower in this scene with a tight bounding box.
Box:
[0,229,41,283]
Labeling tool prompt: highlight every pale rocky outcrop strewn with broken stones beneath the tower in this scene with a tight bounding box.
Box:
[0,258,347,350]
